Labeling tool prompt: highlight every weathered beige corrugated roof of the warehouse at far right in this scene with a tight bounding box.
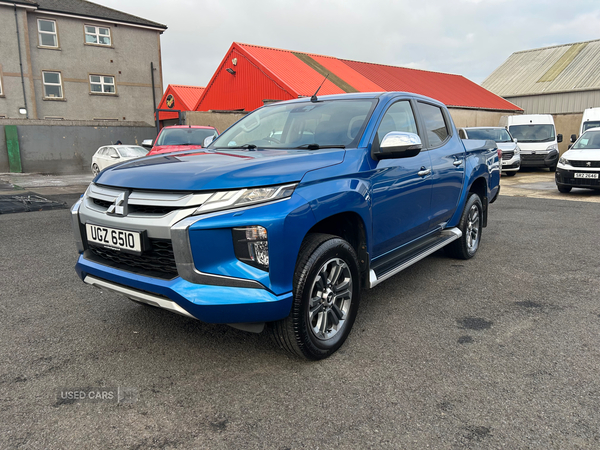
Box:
[481,39,600,97]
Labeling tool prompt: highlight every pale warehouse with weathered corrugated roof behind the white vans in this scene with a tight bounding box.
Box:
[481,40,600,114]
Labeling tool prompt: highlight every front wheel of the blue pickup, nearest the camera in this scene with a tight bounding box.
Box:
[269,233,360,360]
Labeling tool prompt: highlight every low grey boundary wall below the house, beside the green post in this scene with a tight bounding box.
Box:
[0,120,156,174]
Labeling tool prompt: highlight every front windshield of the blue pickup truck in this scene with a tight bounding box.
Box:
[210,99,376,150]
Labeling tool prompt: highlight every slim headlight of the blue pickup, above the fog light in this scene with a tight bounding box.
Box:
[194,183,297,214]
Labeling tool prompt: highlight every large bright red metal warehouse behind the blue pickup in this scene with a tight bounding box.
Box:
[194,42,521,112]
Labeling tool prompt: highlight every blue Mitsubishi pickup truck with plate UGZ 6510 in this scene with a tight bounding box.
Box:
[71,92,501,359]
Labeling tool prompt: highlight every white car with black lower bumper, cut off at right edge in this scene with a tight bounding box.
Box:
[555,127,600,193]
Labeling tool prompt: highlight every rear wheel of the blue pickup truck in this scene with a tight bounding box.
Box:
[444,193,483,259]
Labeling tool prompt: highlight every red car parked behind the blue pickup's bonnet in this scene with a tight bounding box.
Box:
[148,125,219,156]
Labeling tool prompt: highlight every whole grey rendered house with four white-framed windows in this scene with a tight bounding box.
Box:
[0,0,167,124]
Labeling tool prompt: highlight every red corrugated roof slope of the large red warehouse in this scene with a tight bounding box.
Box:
[221,43,520,111]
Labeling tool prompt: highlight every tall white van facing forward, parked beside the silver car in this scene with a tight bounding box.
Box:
[500,114,562,172]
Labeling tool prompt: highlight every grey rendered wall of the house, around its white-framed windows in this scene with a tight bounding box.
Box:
[0,5,162,124]
